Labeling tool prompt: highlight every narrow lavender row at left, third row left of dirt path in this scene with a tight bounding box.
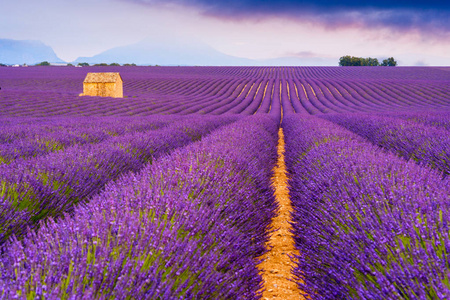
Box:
[0,116,171,163]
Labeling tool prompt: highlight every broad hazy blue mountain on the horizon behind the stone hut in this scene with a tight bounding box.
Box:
[73,38,255,66]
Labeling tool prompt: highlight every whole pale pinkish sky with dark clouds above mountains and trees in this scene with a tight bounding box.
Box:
[0,0,450,66]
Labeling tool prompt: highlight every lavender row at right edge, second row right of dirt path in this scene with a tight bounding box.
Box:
[323,114,450,175]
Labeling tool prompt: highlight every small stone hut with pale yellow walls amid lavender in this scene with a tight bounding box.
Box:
[80,72,123,98]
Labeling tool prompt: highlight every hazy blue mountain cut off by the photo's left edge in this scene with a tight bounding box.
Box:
[0,39,64,65]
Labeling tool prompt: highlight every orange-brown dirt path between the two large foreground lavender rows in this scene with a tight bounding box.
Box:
[259,128,304,299]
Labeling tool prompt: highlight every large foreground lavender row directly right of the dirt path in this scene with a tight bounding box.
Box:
[283,115,450,299]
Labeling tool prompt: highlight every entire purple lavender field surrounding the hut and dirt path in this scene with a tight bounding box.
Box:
[0,67,450,299]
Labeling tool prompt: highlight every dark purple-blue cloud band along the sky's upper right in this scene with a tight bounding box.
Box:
[123,0,450,33]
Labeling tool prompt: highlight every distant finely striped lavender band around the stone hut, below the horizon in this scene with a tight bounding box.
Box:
[0,67,450,117]
